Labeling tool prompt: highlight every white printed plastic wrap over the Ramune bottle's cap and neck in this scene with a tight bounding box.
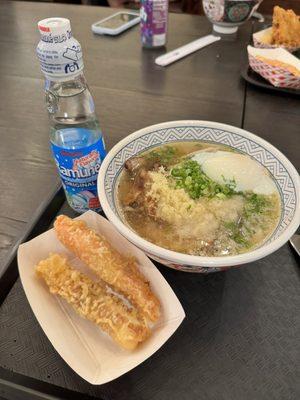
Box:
[37,18,83,80]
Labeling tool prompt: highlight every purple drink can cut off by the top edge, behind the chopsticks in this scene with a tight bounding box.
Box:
[140,0,169,48]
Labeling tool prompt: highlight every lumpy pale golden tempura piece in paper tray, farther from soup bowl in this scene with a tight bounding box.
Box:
[36,254,150,350]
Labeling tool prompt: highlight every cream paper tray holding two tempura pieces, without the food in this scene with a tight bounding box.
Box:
[18,211,185,384]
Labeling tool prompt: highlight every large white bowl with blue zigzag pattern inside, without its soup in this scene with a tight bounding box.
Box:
[98,121,300,273]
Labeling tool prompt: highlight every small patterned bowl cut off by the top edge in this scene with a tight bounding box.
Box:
[202,0,262,34]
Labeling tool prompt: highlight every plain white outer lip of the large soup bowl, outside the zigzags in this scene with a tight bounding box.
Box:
[97,120,300,268]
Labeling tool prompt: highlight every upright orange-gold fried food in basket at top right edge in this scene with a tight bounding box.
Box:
[272,6,300,47]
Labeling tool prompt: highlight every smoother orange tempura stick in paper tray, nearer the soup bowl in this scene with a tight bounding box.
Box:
[54,215,160,322]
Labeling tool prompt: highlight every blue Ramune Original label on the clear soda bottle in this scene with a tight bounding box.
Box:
[51,138,106,213]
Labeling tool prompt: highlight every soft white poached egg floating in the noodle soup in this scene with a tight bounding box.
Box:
[192,151,276,195]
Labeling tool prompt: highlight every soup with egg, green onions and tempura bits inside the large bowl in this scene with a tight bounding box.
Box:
[117,142,280,256]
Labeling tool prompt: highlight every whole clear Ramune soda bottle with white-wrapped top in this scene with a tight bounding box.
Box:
[37,18,106,213]
